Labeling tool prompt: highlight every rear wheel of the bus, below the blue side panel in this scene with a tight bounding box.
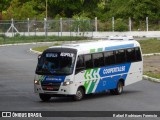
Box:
[110,81,123,95]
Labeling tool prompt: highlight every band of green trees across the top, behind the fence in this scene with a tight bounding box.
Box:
[0,0,160,26]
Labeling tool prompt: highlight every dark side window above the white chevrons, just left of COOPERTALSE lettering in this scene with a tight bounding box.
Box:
[92,53,104,67]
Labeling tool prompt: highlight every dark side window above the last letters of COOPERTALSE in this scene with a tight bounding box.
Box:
[116,50,126,63]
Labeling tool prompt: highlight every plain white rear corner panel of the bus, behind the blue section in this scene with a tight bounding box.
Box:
[125,61,143,85]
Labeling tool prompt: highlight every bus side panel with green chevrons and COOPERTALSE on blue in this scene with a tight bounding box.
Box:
[75,63,131,94]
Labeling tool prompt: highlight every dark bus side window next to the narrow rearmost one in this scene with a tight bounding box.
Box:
[126,48,136,62]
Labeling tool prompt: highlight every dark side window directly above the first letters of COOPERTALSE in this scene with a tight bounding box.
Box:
[104,51,115,65]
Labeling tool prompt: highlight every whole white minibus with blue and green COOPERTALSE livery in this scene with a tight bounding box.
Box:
[34,40,143,101]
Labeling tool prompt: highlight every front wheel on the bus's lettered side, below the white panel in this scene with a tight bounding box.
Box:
[73,87,84,101]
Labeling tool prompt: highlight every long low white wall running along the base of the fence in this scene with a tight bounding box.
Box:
[4,31,160,38]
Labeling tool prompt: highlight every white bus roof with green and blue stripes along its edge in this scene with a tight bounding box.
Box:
[50,40,140,54]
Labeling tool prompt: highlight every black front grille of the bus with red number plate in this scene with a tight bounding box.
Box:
[42,82,61,91]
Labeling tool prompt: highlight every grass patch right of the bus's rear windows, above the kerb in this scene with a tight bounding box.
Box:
[138,39,160,54]
